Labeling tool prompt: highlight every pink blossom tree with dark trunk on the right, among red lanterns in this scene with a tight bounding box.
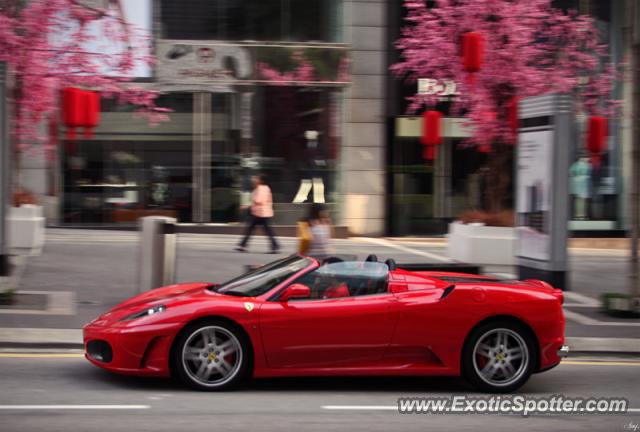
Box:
[392,0,616,211]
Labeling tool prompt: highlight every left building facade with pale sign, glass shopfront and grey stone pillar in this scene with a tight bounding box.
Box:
[41,0,387,234]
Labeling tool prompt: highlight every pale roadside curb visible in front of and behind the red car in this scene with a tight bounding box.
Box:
[0,327,640,356]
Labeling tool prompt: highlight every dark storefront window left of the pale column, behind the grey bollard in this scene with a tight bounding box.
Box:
[62,94,192,225]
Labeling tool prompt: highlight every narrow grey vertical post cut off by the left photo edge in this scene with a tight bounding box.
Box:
[0,62,11,276]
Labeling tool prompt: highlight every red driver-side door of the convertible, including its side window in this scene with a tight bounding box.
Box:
[260,263,395,368]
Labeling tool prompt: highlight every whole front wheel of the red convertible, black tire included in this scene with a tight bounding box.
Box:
[171,319,252,391]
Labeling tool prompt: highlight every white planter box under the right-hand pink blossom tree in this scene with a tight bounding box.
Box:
[447,222,516,265]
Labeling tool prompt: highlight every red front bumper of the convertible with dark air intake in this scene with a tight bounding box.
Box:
[83,323,182,376]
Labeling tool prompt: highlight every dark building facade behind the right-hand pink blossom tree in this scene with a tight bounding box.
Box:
[386,0,632,235]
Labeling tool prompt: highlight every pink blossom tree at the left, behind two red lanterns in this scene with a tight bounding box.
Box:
[0,0,167,157]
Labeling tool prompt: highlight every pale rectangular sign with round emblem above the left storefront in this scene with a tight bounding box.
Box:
[157,41,253,83]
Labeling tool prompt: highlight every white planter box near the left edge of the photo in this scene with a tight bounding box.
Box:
[7,204,44,253]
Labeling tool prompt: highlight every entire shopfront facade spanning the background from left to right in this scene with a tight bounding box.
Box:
[22,0,632,235]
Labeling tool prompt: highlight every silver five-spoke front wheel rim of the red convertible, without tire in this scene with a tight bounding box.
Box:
[182,326,243,387]
